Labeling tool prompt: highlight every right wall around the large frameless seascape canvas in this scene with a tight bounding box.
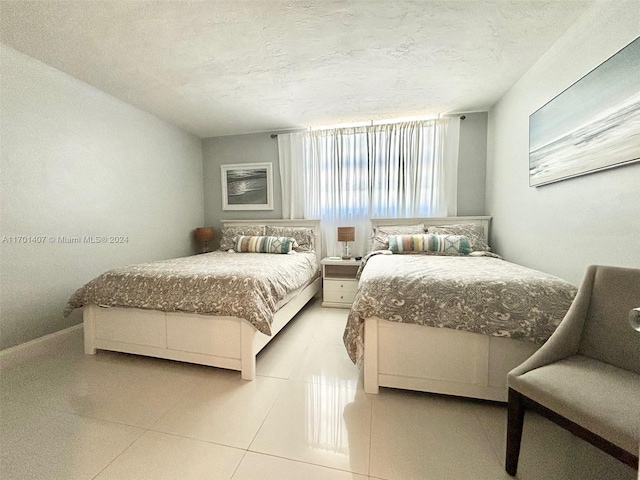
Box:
[487,1,640,284]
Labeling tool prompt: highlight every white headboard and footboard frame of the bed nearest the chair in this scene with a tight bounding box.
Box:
[364,216,539,402]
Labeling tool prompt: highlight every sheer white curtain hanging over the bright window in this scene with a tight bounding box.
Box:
[278,118,460,255]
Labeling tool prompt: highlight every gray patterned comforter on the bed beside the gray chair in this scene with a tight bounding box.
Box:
[344,255,577,364]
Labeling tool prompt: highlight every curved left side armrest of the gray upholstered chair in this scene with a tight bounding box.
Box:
[509,265,597,377]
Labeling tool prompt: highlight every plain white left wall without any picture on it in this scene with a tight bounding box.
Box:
[0,45,204,348]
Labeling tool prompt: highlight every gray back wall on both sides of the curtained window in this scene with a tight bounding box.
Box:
[202,116,487,248]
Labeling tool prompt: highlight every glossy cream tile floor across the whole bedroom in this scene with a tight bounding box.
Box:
[0,299,636,480]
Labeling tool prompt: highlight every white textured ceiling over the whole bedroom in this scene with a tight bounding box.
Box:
[0,0,593,137]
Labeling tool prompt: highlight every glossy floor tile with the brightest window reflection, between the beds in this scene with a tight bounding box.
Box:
[249,379,371,475]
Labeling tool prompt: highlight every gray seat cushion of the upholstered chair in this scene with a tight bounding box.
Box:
[509,355,640,454]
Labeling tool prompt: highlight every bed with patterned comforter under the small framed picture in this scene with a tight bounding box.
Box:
[65,220,322,380]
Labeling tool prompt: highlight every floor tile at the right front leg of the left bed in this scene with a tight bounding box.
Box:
[151,370,286,448]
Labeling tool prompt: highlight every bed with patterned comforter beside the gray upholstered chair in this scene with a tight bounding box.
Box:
[344,217,576,402]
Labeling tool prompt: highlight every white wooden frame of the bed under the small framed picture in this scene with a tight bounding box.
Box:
[83,219,322,380]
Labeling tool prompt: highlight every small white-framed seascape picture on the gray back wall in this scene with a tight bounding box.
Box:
[221,163,273,210]
